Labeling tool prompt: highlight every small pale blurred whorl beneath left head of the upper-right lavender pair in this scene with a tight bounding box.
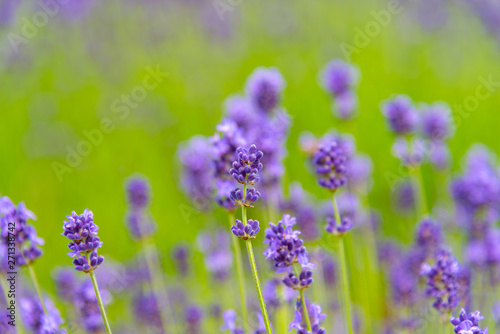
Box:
[392,137,429,167]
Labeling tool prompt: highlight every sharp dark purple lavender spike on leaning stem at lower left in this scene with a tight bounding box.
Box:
[61,209,104,273]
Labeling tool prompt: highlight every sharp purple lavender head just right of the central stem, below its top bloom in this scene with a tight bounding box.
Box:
[264,215,314,272]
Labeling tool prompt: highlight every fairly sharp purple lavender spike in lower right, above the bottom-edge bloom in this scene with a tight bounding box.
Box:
[421,250,461,314]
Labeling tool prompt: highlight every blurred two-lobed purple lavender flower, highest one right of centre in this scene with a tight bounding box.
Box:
[321,59,360,120]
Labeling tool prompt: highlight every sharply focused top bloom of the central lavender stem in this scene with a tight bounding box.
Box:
[229,145,264,185]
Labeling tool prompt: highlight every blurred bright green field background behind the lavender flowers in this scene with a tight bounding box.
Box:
[0,0,500,308]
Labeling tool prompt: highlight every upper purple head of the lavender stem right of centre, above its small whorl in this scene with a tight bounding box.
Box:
[313,141,347,191]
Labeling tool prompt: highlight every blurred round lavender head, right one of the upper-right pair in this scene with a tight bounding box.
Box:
[421,103,452,141]
